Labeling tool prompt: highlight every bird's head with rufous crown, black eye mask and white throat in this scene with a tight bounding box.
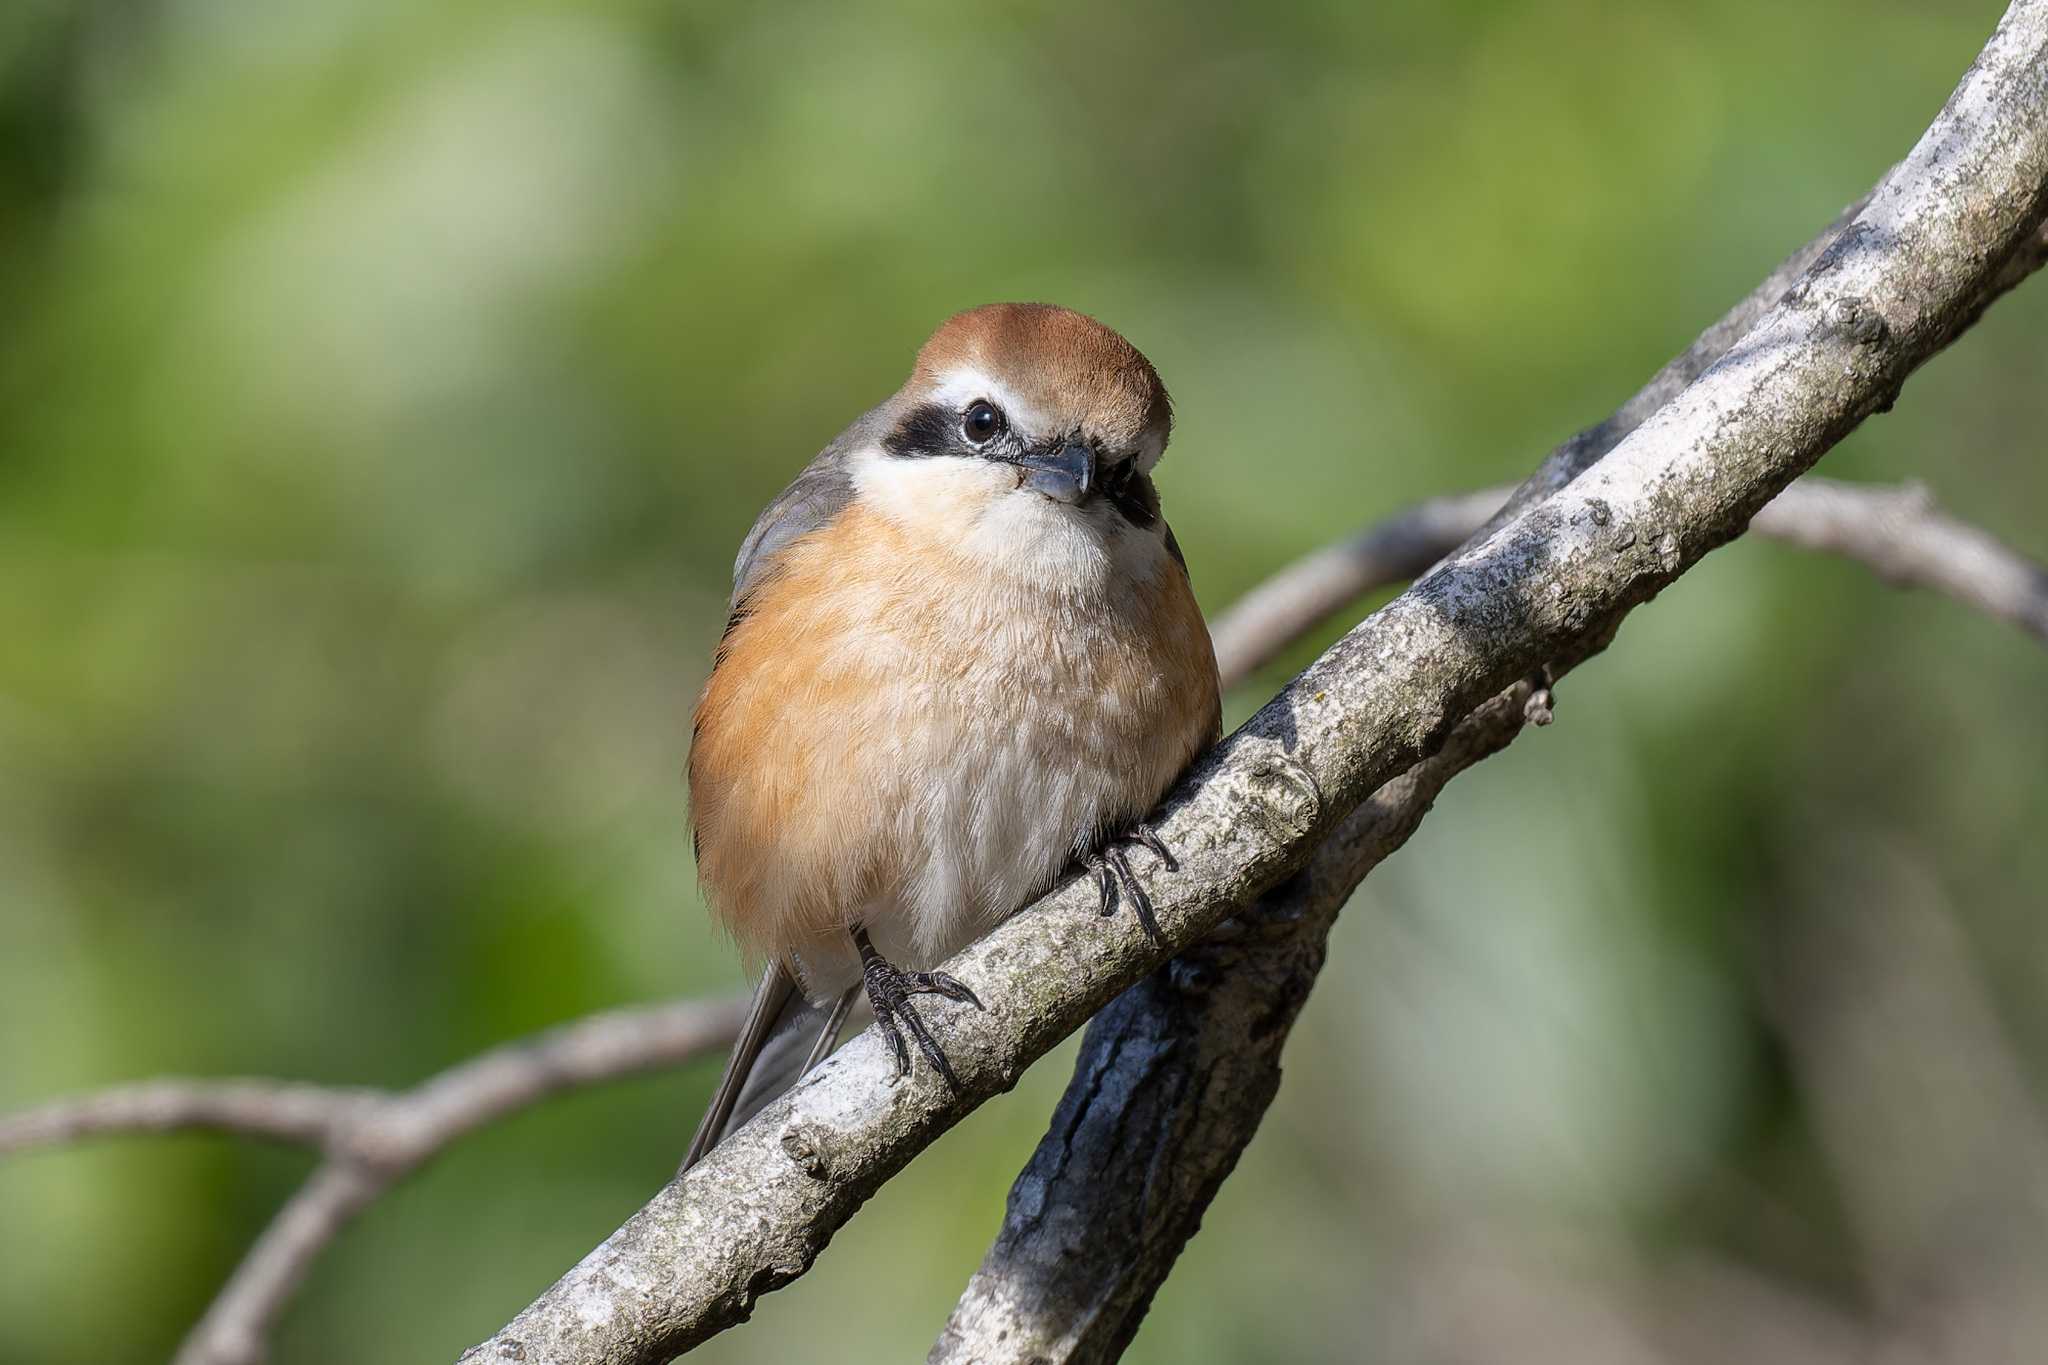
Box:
[856,303,1174,577]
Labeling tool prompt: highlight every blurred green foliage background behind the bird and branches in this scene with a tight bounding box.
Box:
[0,0,2048,1365]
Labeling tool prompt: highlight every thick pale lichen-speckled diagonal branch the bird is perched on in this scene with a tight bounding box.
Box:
[465,0,2048,1365]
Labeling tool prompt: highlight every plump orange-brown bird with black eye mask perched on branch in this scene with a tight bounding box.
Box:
[682,303,1223,1171]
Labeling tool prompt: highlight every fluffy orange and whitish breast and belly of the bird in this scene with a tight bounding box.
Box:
[690,505,1219,995]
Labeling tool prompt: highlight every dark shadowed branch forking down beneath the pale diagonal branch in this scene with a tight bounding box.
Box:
[930,695,1540,1365]
